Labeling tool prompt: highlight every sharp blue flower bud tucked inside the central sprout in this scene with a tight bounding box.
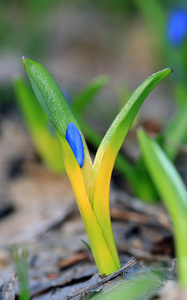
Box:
[66,123,84,168]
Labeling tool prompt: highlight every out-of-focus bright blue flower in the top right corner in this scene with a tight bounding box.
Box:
[167,8,187,47]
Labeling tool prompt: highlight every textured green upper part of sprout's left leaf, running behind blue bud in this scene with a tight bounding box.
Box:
[22,57,92,191]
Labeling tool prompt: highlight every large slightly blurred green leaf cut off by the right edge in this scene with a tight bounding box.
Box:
[138,130,187,287]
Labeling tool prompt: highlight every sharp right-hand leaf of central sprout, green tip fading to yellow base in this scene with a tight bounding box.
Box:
[90,69,172,270]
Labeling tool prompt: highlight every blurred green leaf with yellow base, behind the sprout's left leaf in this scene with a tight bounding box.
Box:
[14,78,65,174]
